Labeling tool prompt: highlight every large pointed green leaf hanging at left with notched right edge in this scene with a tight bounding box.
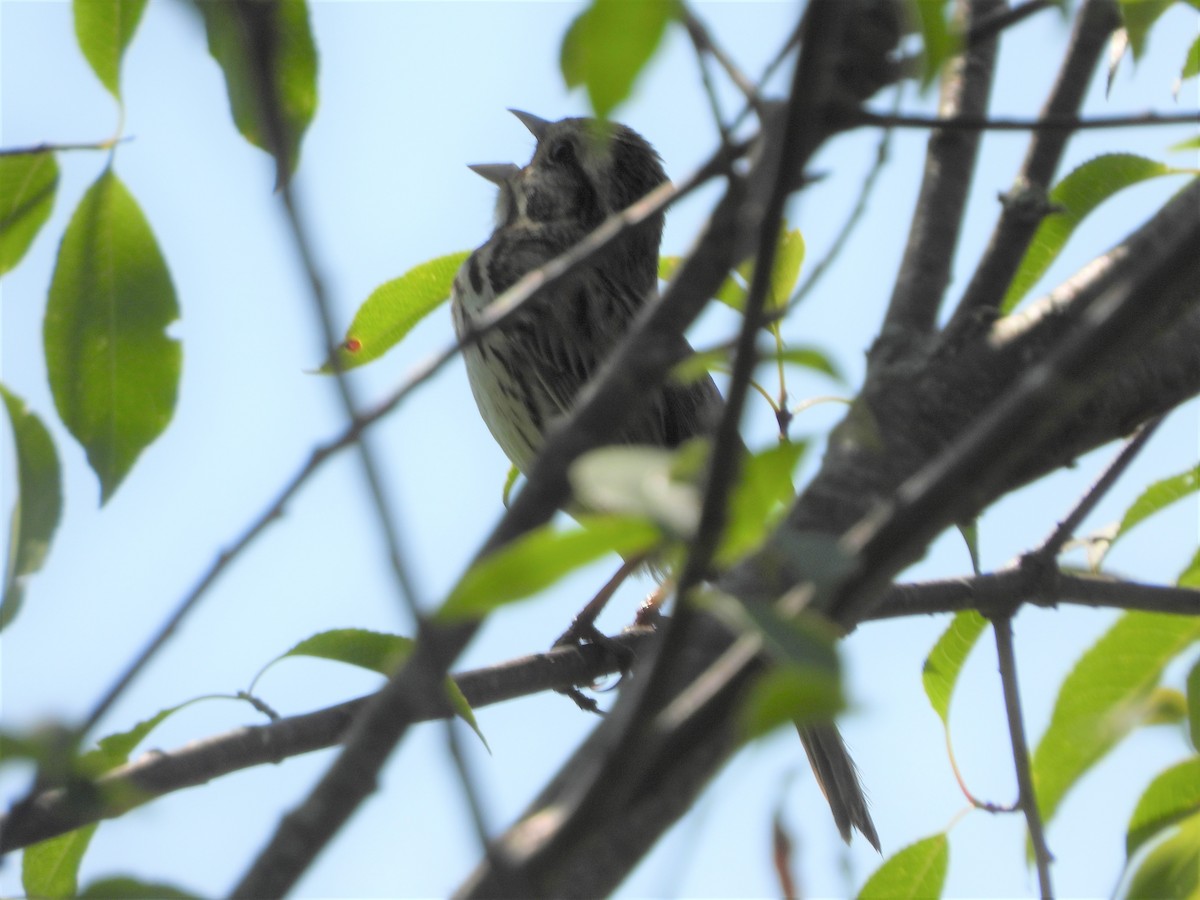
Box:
[43,169,182,502]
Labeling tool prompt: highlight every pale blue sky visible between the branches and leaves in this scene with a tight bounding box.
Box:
[0,0,1200,896]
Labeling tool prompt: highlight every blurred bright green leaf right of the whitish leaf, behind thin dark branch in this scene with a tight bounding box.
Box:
[716,442,808,568]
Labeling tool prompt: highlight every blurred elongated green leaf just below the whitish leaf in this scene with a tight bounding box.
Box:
[438,516,660,622]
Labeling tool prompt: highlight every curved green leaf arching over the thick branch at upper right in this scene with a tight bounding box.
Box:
[1001,154,1187,312]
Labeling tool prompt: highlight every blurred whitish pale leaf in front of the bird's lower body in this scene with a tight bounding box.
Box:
[568,442,707,539]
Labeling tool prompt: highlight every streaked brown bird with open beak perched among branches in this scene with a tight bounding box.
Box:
[450,109,880,850]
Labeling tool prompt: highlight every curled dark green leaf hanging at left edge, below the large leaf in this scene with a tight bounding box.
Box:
[0,385,62,630]
